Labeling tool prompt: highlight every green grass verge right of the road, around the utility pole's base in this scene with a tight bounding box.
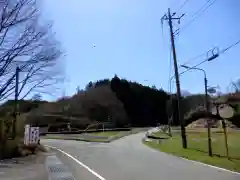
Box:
[144,131,240,172]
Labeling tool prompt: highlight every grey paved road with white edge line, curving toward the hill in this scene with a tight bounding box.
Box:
[43,133,240,180]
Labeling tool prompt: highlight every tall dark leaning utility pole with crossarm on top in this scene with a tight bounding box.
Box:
[162,8,187,148]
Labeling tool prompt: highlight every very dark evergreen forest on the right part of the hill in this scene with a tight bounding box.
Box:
[110,76,168,126]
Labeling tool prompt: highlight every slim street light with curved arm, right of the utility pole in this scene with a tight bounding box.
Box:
[181,64,212,156]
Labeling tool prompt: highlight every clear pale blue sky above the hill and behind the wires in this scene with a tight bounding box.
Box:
[43,0,240,100]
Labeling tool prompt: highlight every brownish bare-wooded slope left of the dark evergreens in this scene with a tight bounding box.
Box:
[28,85,127,129]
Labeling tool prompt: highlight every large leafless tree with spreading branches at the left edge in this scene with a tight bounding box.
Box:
[0,0,62,100]
